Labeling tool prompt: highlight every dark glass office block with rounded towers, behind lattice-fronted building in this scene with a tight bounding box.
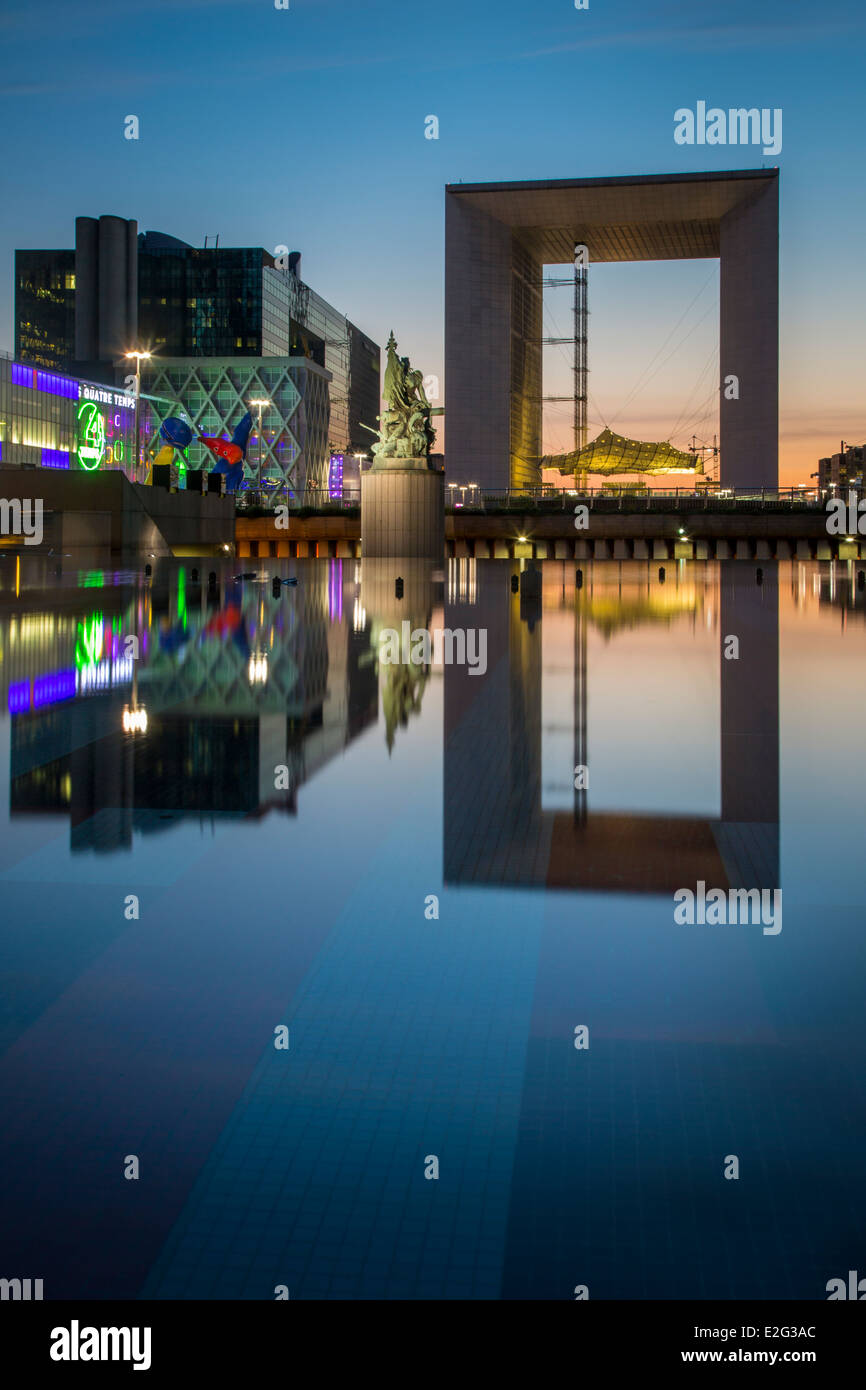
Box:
[15,217,379,453]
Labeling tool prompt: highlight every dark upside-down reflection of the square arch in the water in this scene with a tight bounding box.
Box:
[443,560,778,894]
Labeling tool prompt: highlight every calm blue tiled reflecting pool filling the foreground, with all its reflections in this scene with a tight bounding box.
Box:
[0,556,866,1300]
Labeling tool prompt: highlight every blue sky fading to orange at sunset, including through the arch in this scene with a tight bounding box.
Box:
[0,0,866,482]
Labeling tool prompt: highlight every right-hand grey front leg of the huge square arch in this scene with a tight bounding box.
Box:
[719,181,778,488]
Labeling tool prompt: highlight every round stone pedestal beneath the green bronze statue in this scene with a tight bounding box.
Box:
[361,459,445,562]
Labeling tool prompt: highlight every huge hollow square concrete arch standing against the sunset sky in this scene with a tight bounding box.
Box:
[445,168,778,489]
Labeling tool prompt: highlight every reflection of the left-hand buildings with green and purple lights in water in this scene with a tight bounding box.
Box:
[0,560,378,851]
